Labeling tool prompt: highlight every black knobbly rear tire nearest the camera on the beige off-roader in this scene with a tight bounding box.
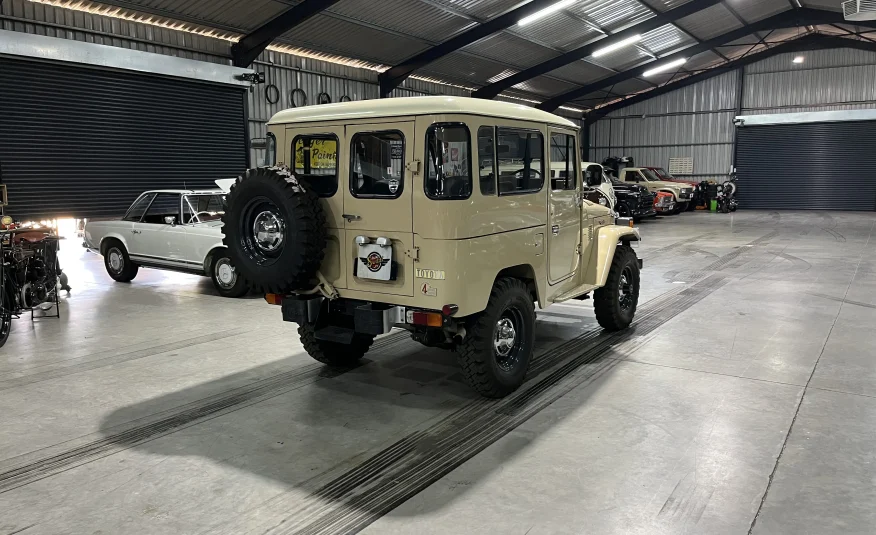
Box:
[456,278,535,398]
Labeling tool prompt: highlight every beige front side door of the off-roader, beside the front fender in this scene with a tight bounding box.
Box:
[548,129,582,284]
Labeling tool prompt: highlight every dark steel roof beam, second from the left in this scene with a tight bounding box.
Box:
[378,0,557,98]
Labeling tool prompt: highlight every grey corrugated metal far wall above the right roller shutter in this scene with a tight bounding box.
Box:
[590,49,876,180]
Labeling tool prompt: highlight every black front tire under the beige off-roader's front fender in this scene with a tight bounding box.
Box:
[593,245,639,331]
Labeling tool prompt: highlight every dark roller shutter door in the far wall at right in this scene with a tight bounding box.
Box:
[737,121,876,211]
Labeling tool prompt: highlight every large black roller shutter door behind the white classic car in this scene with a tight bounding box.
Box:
[0,57,248,220]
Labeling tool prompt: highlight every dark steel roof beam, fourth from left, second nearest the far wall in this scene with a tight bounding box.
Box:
[536,8,872,111]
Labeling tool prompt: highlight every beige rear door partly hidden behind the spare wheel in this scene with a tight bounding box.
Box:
[284,126,349,289]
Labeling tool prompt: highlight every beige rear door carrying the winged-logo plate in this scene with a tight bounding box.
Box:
[342,121,422,296]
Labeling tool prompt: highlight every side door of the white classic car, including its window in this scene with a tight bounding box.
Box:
[130,192,186,266]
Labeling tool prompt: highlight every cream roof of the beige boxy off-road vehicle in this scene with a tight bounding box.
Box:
[268,96,578,129]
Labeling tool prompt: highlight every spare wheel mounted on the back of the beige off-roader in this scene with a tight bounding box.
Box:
[222,167,326,294]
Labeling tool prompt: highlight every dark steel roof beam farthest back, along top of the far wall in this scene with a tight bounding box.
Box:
[584,34,876,125]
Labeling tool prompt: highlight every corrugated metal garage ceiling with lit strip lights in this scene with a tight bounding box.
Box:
[22,0,876,116]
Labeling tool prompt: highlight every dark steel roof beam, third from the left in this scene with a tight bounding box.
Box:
[472,0,721,98]
